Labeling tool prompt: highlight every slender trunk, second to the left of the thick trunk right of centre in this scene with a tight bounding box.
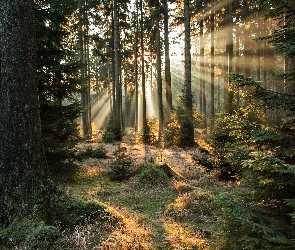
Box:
[156,0,164,140]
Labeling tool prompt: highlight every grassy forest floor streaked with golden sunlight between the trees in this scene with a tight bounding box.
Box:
[65,131,248,250]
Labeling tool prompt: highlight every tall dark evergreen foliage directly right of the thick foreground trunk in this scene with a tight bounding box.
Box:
[35,0,81,179]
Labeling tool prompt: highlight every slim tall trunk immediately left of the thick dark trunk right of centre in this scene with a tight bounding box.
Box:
[164,0,172,123]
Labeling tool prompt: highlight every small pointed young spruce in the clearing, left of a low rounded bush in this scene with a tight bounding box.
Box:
[108,144,133,181]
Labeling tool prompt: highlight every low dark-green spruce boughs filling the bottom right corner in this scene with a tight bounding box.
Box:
[216,193,295,250]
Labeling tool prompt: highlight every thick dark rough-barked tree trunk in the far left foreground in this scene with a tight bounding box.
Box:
[0,0,48,226]
